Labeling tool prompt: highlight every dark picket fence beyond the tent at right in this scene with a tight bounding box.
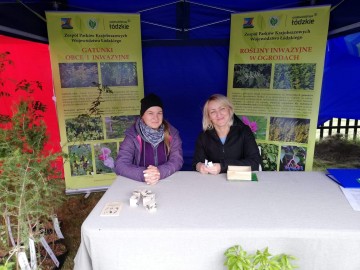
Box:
[316,118,360,140]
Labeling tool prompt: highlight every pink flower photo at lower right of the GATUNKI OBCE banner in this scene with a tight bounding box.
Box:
[94,142,117,174]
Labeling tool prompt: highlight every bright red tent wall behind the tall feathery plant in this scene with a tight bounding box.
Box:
[0,35,63,175]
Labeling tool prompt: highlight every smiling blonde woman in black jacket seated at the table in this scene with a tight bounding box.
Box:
[192,94,261,174]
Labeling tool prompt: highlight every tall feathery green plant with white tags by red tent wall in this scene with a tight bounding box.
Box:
[0,52,63,269]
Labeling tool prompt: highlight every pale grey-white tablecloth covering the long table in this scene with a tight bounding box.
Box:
[75,172,360,270]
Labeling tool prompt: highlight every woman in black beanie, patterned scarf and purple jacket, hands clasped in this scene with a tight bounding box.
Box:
[115,94,184,185]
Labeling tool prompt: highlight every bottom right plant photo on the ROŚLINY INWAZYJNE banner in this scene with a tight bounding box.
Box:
[279,145,306,171]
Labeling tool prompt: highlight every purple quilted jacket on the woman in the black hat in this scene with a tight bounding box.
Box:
[114,120,184,182]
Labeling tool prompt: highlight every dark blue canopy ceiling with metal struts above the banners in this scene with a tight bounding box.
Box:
[0,0,360,43]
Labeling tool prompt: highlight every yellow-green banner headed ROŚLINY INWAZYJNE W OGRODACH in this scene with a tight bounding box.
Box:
[227,6,330,171]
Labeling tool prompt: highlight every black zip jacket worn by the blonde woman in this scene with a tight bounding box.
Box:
[192,115,261,173]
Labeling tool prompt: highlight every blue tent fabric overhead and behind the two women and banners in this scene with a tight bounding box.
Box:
[0,0,360,170]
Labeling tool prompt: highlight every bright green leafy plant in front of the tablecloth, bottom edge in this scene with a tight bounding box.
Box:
[224,245,297,270]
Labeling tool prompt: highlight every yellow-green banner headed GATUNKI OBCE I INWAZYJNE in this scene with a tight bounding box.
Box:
[46,12,144,193]
